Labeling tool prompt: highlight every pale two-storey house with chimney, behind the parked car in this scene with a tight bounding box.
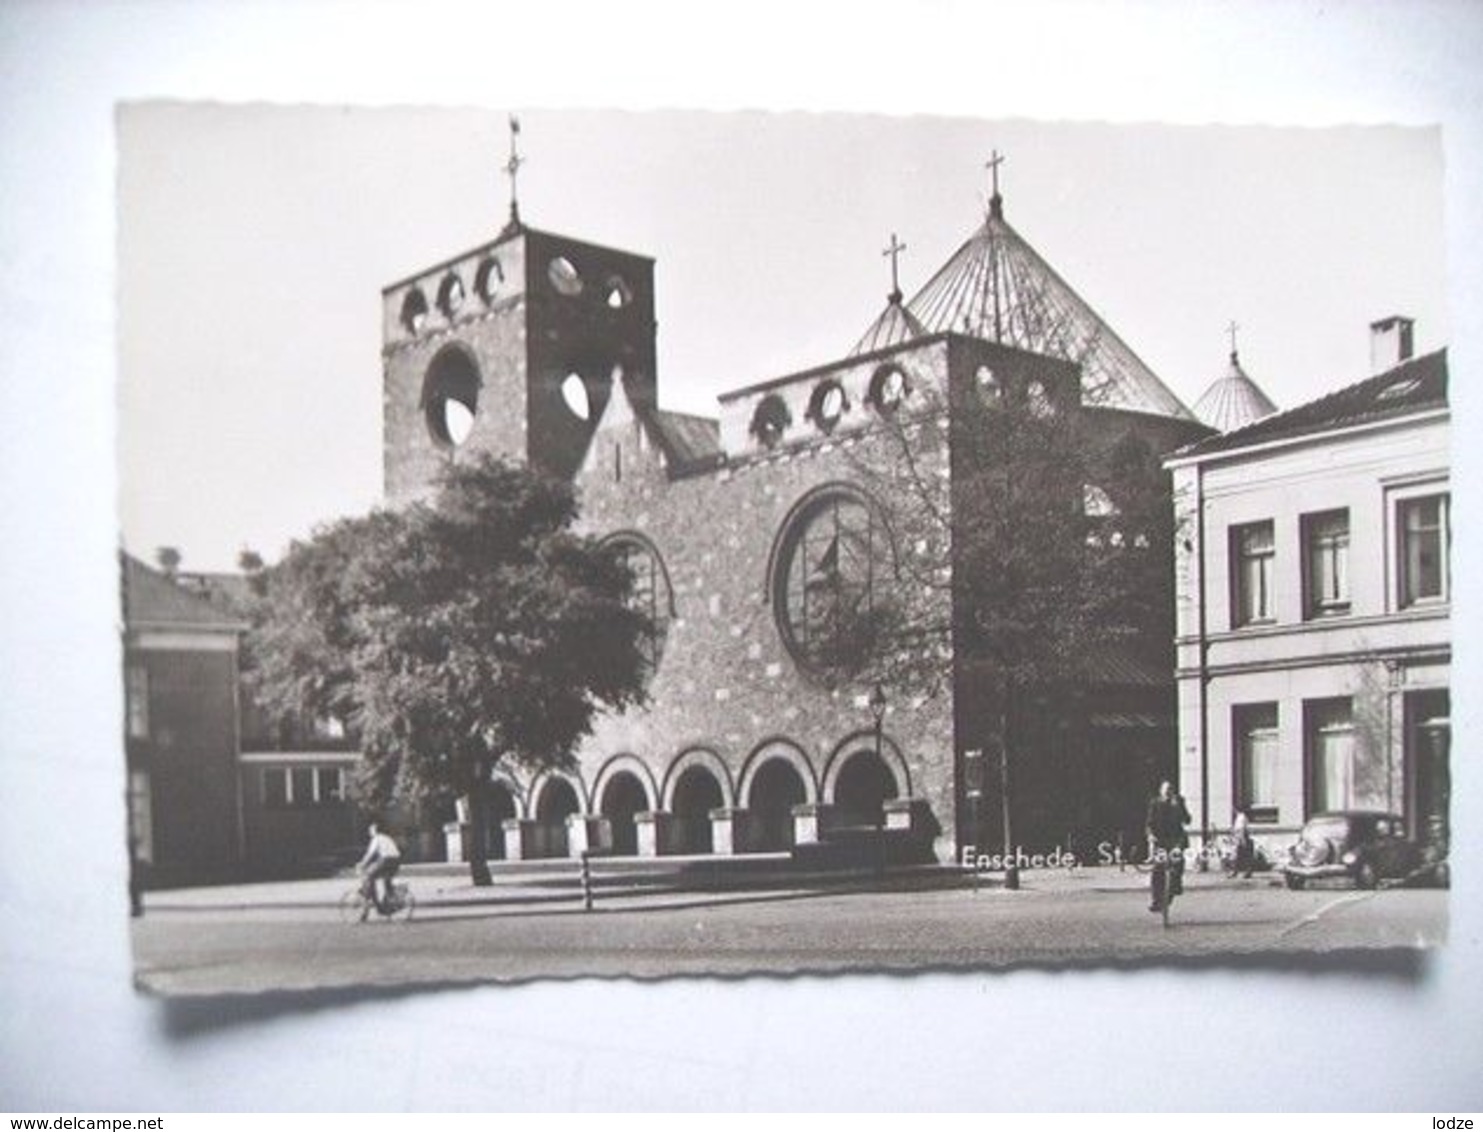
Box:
[1166,327,1452,847]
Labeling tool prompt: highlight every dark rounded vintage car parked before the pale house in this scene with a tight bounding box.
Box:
[1281,810,1428,889]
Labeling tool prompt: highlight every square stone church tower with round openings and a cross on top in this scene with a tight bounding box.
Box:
[381,119,657,503]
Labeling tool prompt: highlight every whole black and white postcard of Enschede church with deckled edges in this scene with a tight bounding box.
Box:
[117,102,1453,994]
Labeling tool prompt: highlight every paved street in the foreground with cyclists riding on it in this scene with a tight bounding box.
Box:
[133,869,1446,994]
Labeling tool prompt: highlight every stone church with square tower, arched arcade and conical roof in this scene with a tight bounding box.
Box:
[383,172,1209,859]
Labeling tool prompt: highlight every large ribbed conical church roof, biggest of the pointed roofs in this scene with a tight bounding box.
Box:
[906,193,1194,420]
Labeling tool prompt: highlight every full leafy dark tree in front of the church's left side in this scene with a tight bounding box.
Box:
[249,458,653,883]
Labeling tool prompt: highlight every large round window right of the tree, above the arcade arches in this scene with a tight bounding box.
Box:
[773,487,890,674]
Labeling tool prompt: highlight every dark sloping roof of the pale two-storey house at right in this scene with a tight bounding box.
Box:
[1176,350,1447,457]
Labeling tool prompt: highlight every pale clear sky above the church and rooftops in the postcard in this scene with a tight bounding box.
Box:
[117,101,1447,570]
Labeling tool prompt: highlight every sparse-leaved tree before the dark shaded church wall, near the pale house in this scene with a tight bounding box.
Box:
[851,368,1173,866]
